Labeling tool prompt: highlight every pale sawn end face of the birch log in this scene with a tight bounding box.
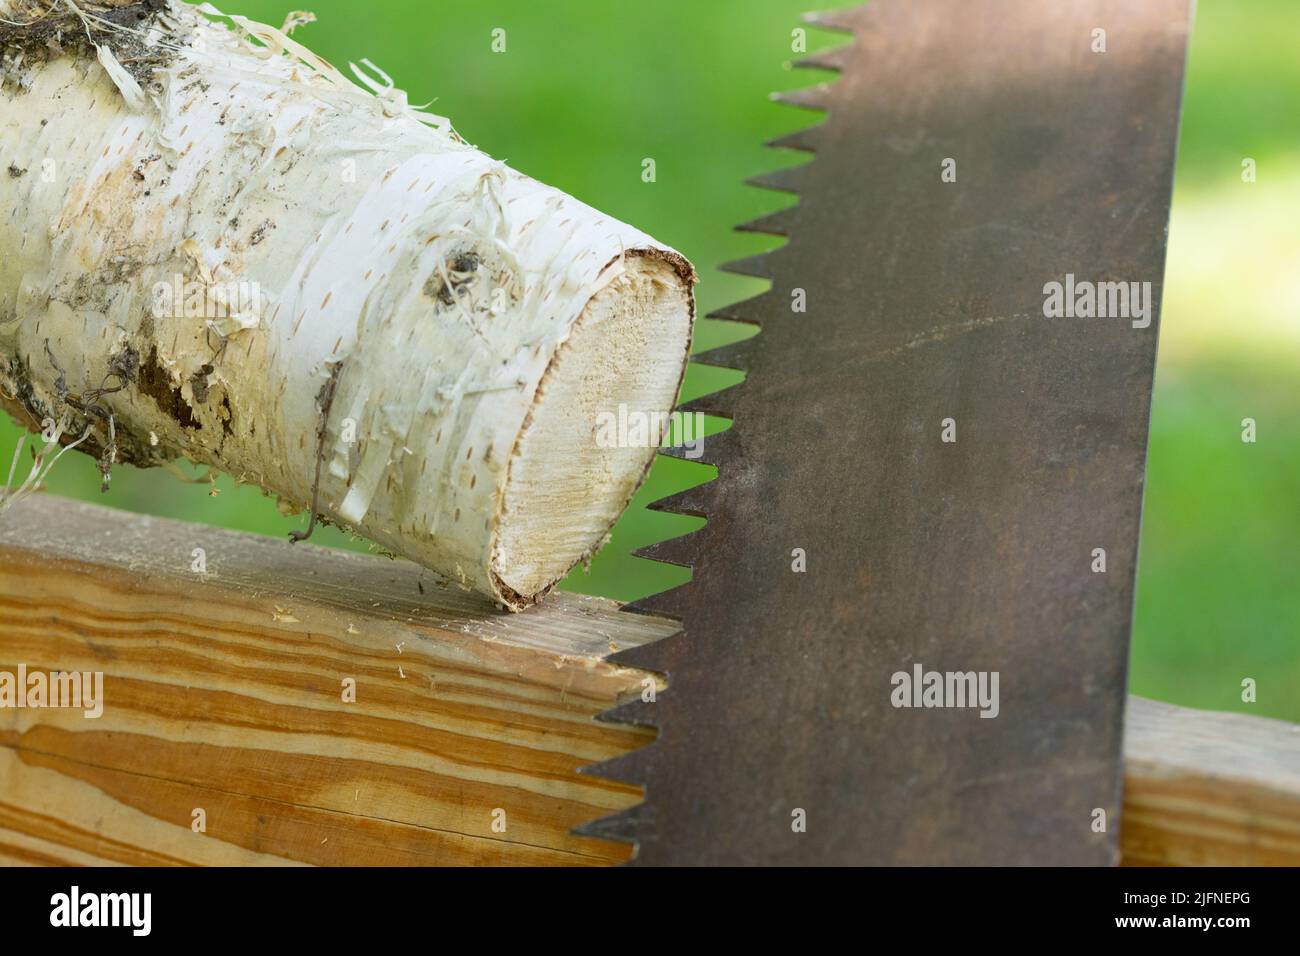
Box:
[491,250,694,610]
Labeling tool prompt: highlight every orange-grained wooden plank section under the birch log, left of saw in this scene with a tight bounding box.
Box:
[0,497,673,865]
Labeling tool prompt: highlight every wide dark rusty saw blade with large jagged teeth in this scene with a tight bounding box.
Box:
[584,0,1190,864]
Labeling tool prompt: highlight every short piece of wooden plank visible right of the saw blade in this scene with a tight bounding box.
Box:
[1121,697,1300,866]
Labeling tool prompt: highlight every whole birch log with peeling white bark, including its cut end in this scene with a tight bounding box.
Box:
[0,0,694,610]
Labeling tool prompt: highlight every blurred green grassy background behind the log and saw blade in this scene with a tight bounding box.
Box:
[0,0,1300,721]
